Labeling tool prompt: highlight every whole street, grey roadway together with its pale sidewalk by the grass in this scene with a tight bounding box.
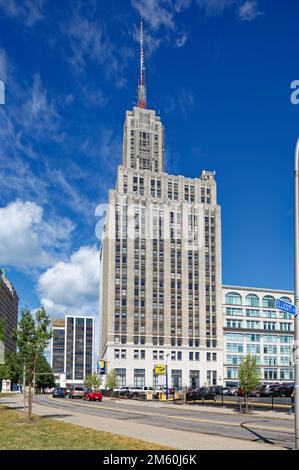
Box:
[2,395,294,450]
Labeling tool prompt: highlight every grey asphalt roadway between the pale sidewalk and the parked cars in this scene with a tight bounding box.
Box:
[34,395,294,449]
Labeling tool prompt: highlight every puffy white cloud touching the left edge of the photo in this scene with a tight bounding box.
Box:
[0,200,74,270]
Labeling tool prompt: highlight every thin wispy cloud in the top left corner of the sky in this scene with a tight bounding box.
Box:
[0,0,44,27]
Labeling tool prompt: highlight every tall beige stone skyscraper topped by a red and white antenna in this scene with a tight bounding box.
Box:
[100,24,223,388]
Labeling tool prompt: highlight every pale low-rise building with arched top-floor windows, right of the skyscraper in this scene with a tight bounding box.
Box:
[222,286,294,385]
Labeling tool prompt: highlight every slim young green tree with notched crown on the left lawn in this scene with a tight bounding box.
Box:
[14,308,52,420]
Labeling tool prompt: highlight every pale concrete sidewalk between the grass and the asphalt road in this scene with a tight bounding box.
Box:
[0,397,284,450]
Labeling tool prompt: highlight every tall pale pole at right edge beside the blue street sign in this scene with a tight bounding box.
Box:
[294,138,299,450]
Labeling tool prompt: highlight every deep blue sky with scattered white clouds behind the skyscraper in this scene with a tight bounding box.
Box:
[0,0,299,324]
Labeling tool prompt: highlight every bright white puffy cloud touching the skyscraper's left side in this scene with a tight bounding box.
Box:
[38,246,100,316]
